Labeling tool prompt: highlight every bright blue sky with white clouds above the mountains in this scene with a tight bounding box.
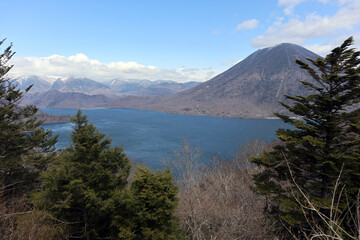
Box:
[0,0,360,82]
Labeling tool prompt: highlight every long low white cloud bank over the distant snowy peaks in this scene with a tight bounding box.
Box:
[10,53,215,82]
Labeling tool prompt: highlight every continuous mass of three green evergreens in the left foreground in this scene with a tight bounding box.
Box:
[0,36,178,239]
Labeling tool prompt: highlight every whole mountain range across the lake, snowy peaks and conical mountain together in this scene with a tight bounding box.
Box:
[19,43,320,118]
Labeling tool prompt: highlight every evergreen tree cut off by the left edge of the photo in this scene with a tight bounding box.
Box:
[0,39,57,197]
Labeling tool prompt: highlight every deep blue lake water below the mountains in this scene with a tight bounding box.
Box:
[41,108,288,168]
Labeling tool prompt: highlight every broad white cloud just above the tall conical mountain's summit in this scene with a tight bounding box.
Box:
[252,0,360,54]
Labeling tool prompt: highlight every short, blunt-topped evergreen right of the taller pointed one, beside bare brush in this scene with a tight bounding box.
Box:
[114,167,179,240]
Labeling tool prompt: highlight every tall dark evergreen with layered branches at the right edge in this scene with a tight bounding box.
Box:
[253,37,360,239]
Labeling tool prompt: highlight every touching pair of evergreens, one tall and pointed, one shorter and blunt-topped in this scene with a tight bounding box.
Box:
[33,110,178,239]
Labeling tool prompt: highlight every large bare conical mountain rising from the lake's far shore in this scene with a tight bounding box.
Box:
[122,43,319,118]
